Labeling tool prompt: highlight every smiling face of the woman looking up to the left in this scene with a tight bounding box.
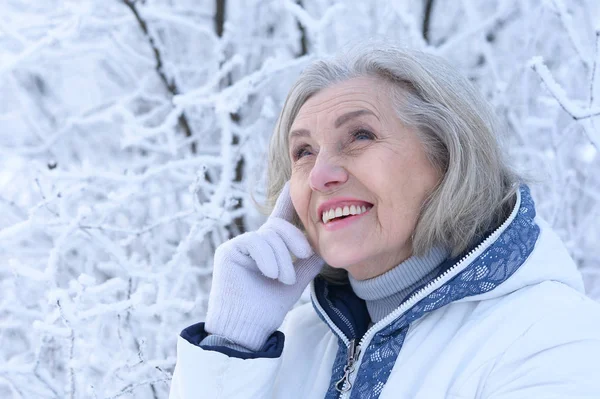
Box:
[289,77,440,280]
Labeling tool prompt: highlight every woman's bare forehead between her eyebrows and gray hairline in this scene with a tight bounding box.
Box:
[293,77,388,125]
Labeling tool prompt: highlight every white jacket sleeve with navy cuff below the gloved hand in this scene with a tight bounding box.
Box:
[169,323,284,399]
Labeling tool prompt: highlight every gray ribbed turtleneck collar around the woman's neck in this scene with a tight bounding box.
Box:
[348,248,450,323]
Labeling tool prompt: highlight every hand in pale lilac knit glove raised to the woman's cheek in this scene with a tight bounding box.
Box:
[204,182,324,351]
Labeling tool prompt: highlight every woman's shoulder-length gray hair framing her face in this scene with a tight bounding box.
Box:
[267,45,521,283]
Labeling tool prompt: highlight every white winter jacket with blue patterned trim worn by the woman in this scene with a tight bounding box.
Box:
[170,186,600,399]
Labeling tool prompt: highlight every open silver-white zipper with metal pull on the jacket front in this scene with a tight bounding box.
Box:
[313,190,521,399]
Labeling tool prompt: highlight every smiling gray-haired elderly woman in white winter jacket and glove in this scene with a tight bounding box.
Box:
[166,47,600,399]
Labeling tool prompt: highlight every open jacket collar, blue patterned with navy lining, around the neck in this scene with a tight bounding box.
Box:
[311,185,540,341]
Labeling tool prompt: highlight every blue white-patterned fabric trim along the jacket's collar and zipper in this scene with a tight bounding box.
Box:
[312,185,540,399]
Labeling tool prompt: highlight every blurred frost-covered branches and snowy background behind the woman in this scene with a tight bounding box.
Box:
[0,0,600,398]
